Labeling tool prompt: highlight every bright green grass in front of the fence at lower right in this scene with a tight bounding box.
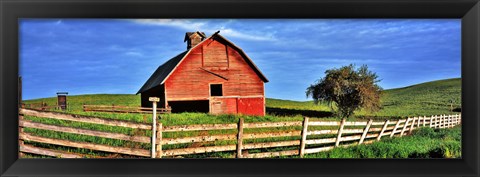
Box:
[306,126,462,158]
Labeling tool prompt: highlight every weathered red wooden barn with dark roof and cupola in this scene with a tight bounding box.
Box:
[137,31,268,116]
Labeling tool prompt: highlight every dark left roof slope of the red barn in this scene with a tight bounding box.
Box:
[137,50,188,94]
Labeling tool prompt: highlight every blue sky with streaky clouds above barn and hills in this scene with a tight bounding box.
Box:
[20,19,461,101]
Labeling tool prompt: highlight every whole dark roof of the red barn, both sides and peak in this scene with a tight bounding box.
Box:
[137,32,268,94]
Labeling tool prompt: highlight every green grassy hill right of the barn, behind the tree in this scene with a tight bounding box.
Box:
[267,78,461,118]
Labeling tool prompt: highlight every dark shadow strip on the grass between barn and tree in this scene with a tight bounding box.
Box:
[266,107,333,117]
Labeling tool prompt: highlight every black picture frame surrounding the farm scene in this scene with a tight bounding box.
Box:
[0,0,480,176]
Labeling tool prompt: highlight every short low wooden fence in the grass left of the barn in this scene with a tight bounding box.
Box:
[83,104,172,113]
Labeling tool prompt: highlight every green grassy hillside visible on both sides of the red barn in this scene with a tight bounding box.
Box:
[25,78,461,119]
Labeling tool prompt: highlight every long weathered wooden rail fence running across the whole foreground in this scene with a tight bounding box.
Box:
[19,109,461,158]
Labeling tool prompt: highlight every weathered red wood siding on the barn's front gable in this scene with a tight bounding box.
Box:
[165,39,264,115]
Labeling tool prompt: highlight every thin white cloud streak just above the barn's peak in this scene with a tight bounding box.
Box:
[131,19,275,41]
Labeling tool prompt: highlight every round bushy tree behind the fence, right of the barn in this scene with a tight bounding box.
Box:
[306,64,382,117]
